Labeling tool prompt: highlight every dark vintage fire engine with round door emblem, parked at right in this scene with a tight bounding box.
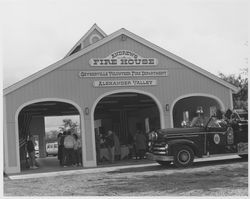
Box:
[147,111,248,167]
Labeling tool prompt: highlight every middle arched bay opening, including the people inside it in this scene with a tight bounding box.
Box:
[94,92,161,164]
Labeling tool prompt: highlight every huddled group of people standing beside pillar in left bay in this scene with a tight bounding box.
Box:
[57,130,82,167]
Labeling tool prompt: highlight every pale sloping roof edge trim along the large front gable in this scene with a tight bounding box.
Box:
[3,25,238,95]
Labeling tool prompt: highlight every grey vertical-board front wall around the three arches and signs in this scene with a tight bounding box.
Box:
[4,33,231,173]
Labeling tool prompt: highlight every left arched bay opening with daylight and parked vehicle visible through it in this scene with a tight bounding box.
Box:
[18,101,81,172]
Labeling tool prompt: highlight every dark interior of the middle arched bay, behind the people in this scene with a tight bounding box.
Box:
[94,92,160,164]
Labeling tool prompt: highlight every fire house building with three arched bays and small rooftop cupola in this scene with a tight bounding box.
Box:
[3,24,237,173]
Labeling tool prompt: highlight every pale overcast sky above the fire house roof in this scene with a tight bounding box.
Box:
[0,0,249,88]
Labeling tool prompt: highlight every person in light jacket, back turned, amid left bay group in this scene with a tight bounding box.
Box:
[64,131,76,167]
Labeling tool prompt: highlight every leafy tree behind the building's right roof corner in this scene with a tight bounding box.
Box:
[219,68,248,110]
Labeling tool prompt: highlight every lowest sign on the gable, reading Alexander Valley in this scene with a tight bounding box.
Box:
[93,79,157,87]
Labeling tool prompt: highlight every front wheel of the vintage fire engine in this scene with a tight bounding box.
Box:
[174,145,194,168]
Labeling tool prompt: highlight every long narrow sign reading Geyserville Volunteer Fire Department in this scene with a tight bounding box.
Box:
[79,70,168,78]
